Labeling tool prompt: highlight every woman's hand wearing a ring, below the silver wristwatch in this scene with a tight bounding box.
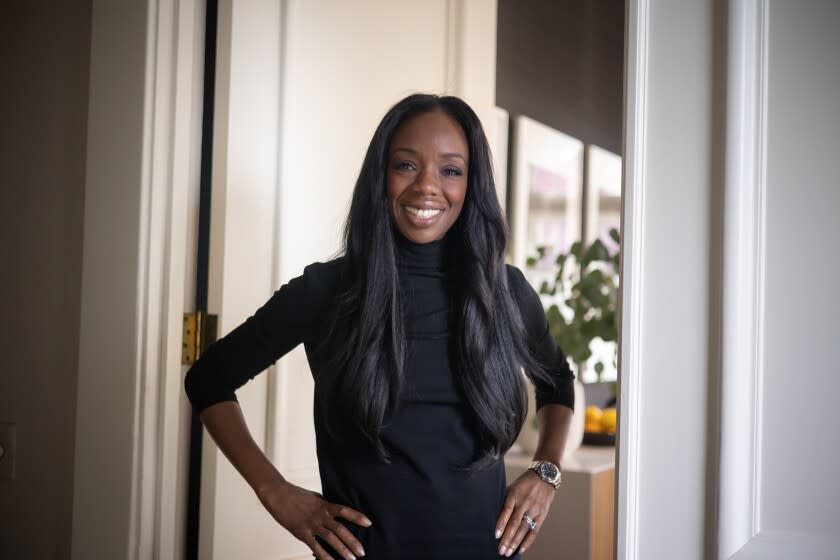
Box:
[496,469,556,556]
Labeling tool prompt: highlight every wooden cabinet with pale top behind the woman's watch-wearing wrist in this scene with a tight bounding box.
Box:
[505,445,615,560]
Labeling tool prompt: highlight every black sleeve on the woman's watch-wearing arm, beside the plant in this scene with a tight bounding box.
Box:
[508,265,575,410]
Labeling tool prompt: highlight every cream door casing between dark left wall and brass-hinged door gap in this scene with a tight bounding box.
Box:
[72,0,204,559]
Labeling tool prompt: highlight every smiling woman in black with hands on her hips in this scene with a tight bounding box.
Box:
[185,94,574,560]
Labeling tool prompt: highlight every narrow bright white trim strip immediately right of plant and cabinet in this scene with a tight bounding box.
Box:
[615,0,649,560]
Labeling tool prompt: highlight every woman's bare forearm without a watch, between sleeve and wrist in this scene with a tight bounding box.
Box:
[200,401,285,494]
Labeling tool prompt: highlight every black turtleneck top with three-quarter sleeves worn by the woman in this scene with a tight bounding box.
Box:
[185,234,574,560]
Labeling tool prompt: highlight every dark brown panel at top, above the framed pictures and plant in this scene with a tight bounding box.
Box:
[496,0,624,154]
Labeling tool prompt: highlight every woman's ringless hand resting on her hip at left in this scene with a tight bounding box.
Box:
[257,481,371,560]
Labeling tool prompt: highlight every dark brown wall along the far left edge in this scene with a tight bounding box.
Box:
[0,0,91,558]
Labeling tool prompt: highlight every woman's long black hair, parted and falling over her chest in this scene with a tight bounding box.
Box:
[316,94,554,469]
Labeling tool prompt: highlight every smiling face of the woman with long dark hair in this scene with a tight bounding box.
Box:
[385,111,469,243]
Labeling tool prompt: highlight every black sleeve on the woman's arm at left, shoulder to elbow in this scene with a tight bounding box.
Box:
[184,261,334,412]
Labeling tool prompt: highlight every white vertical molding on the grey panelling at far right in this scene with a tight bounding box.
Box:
[718,0,768,558]
